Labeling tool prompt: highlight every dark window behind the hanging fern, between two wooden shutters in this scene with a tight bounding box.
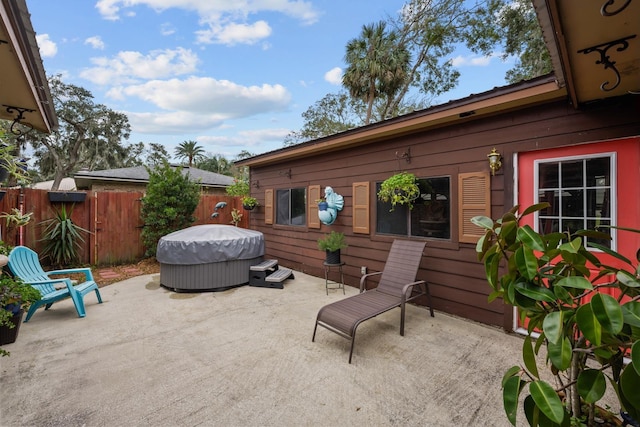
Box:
[376,176,451,239]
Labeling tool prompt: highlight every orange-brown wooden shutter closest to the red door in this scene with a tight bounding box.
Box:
[458,172,491,243]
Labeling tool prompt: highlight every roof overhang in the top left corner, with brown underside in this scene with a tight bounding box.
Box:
[0,0,58,133]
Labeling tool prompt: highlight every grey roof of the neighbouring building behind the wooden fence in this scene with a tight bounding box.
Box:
[74,165,233,188]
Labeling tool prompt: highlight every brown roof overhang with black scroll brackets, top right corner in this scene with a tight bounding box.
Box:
[533,0,640,108]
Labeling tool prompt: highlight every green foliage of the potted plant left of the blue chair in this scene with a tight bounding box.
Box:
[0,274,40,356]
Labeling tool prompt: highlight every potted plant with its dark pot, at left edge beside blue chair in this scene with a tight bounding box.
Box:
[0,274,40,356]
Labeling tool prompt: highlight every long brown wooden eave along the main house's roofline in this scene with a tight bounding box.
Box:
[236,76,567,167]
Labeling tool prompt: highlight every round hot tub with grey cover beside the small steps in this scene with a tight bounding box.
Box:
[156,224,264,292]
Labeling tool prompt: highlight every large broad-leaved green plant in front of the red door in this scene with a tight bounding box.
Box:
[471,203,640,426]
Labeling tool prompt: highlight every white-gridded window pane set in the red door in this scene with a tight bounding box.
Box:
[536,155,615,247]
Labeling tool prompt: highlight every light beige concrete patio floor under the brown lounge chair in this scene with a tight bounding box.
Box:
[0,272,524,426]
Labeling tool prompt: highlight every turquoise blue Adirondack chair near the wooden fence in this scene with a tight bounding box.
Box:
[9,246,102,322]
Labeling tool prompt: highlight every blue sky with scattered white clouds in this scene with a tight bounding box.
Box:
[27,0,513,159]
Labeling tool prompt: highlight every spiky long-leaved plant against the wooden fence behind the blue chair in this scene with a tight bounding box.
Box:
[40,205,89,266]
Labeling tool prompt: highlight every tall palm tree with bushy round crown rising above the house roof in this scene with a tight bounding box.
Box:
[342,21,410,124]
